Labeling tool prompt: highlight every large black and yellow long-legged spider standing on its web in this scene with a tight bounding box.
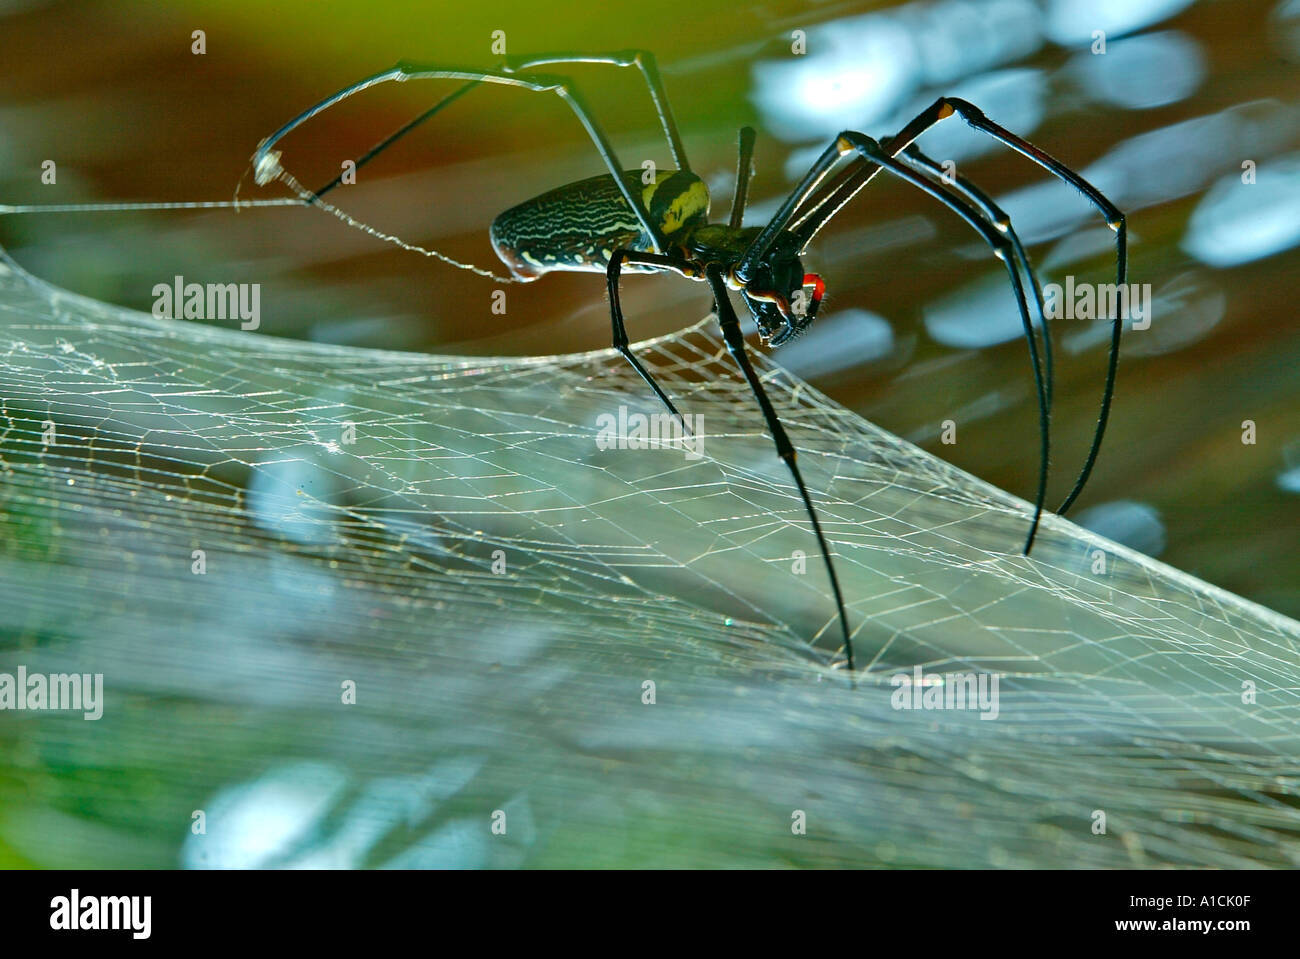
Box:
[245,51,1127,673]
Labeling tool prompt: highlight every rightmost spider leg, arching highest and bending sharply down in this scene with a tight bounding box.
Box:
[785,96,1128,515]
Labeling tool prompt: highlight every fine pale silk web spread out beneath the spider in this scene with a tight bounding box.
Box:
[0,240,1300,867]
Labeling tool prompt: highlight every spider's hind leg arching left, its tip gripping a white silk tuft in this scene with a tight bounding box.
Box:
[252,61,667,252]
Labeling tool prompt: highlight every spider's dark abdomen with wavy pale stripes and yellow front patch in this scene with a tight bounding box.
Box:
[490,170,709,278]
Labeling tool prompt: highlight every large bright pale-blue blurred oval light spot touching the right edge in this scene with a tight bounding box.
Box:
[1182,153,1300,266]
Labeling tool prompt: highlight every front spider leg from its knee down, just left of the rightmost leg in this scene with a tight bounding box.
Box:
[831,130,1050,554]
